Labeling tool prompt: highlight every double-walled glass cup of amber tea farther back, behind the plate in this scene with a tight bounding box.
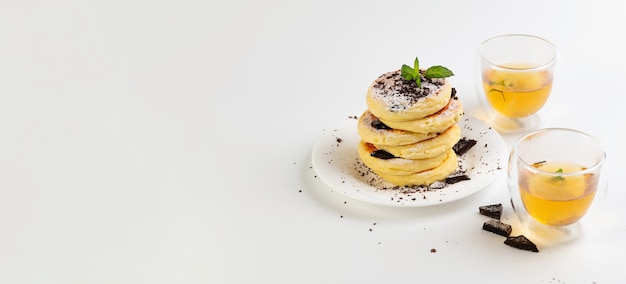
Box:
[475,34,558,132]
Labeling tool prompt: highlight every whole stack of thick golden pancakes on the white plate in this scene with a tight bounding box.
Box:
[358,70,463,186]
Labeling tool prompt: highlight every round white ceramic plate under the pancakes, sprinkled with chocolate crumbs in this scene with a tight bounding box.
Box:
[312,115,508,207]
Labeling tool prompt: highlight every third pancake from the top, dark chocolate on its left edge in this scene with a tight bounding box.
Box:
[357,111,438,146]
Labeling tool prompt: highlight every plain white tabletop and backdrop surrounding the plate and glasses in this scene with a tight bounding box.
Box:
[0,0,626,283]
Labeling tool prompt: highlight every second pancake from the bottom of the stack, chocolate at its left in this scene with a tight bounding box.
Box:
[358,141,448,175]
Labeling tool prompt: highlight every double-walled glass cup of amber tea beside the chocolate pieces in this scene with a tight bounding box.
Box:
[508,128,606,241]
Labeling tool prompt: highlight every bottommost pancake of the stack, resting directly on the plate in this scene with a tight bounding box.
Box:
[370,150,458,186]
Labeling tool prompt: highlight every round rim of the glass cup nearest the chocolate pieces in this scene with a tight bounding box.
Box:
[513,127,606,177]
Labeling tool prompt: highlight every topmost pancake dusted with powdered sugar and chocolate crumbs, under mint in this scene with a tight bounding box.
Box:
[365,70,452,122]
